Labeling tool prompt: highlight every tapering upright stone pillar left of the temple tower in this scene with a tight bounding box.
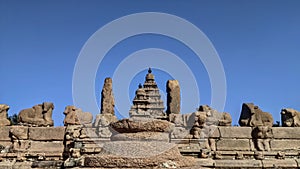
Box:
[101,77,115,115]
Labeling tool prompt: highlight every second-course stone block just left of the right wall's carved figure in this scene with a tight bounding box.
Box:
[216,139,250,151]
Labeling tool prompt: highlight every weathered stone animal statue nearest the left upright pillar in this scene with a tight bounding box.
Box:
[64,106,93,126]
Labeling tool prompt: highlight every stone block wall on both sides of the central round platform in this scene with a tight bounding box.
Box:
[0,125,300,169]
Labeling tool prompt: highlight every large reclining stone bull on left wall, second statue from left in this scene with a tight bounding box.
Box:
[18,102,54,126]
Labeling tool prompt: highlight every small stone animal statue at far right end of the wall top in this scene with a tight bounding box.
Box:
[280,108,300,127]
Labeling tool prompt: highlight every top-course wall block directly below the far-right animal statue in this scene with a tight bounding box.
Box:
[272,127,300,139]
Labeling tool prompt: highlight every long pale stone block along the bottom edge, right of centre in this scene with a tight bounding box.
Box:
[215,160,262,169]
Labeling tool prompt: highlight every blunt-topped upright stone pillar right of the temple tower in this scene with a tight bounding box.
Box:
[167,80,180,115]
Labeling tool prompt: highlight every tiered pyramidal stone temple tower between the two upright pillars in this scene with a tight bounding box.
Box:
[129,68,166,119]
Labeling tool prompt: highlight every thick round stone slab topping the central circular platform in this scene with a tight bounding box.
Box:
[110,118,174,133]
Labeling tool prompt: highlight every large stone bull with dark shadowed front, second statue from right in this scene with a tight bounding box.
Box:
[239,103,273,127]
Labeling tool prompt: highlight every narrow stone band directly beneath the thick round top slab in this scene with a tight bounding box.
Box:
[110,132,169,142]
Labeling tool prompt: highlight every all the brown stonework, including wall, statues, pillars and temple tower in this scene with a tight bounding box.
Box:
[0,68,300,169]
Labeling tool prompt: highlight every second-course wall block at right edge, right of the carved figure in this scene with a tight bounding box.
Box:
[271,139,300,151]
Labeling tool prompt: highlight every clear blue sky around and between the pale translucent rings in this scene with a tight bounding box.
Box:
[0,0,300,126]
